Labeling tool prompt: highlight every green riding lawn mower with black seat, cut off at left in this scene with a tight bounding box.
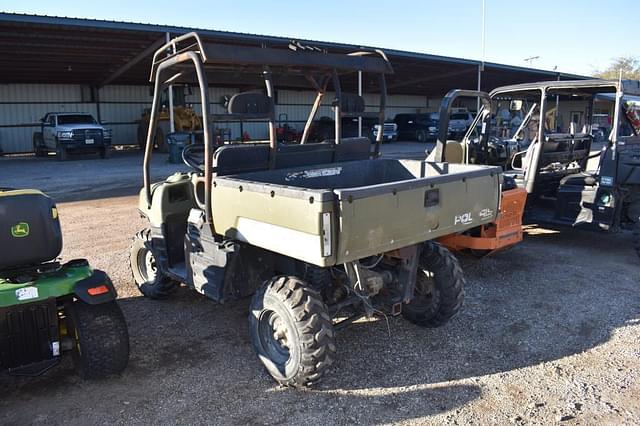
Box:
[0,188,129,379]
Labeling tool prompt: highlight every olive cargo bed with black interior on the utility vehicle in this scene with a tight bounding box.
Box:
[211,159,500,266]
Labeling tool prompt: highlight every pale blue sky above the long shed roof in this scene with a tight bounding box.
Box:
[0,0,640,75]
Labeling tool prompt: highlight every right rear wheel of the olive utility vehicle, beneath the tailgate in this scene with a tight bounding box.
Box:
[402,241,465,327]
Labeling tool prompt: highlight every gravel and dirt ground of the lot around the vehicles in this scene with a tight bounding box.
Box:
[0,148,640,425]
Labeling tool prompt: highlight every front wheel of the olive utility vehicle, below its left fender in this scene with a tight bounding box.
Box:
[129,229,179,299]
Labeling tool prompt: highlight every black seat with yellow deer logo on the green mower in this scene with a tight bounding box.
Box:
[0,189,62,271]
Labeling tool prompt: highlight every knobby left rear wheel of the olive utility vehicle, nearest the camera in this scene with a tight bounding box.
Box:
[249,276,336,388]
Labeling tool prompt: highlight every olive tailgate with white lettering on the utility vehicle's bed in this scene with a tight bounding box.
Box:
[334,163,500,264]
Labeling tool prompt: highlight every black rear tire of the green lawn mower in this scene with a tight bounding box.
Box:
[69,301,129,379]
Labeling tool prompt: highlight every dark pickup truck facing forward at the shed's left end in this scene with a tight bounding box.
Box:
[33,112,111,161]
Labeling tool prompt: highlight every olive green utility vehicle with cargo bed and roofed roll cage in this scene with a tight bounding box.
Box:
[131,33,501,387]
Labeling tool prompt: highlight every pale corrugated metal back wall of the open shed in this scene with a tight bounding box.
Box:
[0,84,439,152]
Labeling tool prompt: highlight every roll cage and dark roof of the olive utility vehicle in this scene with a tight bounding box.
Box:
[143,32,393,222]
